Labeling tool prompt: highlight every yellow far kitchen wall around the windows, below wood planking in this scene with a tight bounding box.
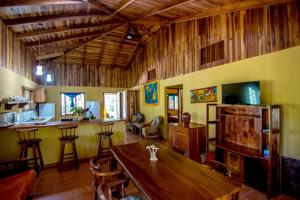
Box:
[43,86,124,120]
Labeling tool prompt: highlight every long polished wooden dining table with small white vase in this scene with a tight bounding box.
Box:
[111,142,242,200]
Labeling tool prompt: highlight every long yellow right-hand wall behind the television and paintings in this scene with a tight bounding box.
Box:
[140,46,300,159]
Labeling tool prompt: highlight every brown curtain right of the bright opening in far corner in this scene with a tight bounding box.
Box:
[126,91,140,121]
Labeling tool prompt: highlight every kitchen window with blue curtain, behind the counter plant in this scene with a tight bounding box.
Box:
[61,93,84,115]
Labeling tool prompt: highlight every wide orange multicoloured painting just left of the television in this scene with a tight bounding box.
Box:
[190,86,217,103]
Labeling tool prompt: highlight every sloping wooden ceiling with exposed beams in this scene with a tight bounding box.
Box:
[0,0,287,68]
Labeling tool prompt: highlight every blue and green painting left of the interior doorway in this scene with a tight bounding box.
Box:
[144,81,159,105]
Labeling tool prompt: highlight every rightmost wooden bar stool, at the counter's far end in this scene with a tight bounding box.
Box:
[97,123,114,160]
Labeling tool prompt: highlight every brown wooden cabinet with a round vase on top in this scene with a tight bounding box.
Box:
[169,123,205,162]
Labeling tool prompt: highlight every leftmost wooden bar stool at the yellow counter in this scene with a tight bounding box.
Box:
[16,128,44,174]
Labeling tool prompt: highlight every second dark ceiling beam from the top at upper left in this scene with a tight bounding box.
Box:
[4,12,107,27]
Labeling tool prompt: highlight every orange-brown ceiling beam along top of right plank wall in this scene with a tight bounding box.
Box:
[163,0,292,24]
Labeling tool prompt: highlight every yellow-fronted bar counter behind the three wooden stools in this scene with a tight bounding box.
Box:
[0,119,125,166]
